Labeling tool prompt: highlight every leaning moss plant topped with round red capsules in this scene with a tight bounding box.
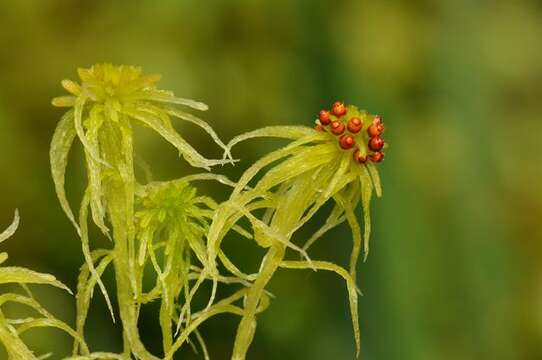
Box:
[207,102,384,360]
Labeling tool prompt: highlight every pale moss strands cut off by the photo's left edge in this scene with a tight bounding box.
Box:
[0,212,88,360]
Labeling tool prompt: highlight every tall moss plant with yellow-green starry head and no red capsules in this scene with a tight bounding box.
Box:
[50,64,236,359]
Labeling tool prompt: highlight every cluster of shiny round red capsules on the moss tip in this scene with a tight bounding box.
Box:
[315,101,384,164]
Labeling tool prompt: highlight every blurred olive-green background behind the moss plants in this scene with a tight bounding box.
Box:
[0,0,542,360]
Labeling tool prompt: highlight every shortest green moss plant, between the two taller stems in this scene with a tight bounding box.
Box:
[136,174,254,354]
